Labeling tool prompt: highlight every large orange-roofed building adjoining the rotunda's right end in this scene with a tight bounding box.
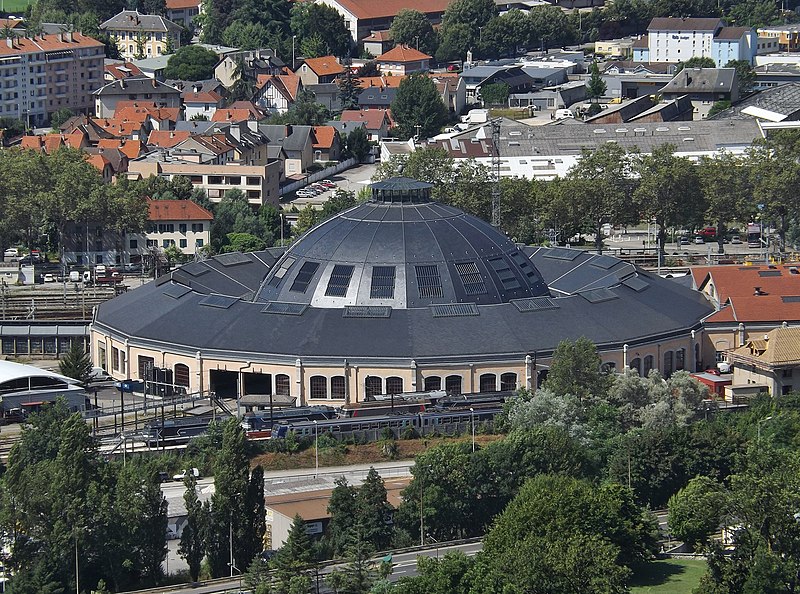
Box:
[691,265,800,366]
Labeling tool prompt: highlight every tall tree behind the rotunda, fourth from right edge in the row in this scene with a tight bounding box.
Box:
[567,144,639,254]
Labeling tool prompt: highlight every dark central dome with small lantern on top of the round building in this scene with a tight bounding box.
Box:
[256,178,549,309]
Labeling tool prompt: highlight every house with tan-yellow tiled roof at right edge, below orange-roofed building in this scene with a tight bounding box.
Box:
[726,327,800,396]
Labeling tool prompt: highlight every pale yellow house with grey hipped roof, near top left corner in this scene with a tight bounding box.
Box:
[100,10,181,60]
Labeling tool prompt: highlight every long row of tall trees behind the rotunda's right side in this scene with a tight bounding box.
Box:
[375,131,800,253]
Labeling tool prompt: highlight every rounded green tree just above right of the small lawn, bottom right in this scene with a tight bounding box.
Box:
[668,476,724,548]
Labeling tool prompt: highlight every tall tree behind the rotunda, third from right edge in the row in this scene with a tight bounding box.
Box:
[634,144,705,261]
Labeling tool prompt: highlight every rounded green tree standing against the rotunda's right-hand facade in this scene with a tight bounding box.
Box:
[544,337,611,402]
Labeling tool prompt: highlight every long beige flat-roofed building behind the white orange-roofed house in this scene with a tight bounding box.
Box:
[128,151,280,207]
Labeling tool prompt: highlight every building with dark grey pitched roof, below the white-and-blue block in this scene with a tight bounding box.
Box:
[660,68,739,120]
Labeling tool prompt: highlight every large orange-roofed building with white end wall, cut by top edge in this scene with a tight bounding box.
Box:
[320,0,452,43]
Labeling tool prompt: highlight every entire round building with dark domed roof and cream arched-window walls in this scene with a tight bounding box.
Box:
[91,178,712,404]
